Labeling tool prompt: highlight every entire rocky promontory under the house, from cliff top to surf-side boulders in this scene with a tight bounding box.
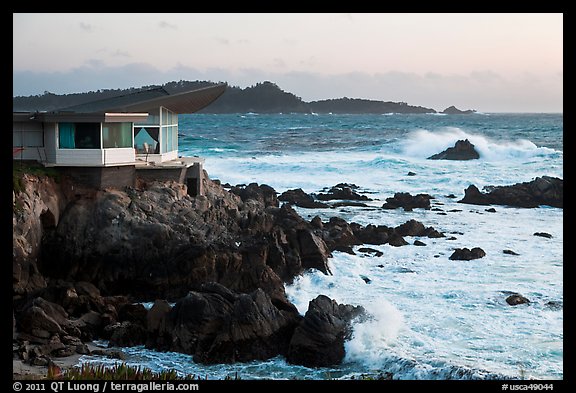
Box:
[13,174,443,364]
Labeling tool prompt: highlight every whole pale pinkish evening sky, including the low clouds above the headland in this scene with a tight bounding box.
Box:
[12,13,564,113]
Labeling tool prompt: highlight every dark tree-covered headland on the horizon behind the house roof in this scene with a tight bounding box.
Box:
[12,80,475,114]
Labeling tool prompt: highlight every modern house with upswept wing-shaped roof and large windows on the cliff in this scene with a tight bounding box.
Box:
[12,84,226,195]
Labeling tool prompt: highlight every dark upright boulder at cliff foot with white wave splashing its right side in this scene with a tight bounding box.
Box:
[286,295,364,367]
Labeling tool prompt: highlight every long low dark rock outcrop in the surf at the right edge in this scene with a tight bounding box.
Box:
[458,176,564,208]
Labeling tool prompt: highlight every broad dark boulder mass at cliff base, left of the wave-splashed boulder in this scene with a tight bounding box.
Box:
[147,283,301,364]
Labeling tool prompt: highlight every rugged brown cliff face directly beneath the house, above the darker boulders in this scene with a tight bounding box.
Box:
[13,174,330,304]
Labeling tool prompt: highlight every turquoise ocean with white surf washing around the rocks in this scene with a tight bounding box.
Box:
[81,113,564,380]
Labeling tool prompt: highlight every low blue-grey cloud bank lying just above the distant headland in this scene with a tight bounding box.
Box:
[13,59,563,112]
